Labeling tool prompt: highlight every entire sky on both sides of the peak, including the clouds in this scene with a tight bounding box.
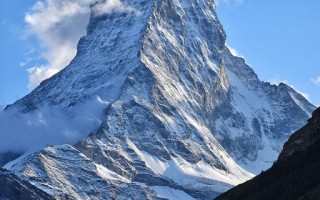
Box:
[0,0,320,105]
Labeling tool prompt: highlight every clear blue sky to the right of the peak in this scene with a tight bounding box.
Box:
[218,0,320,106]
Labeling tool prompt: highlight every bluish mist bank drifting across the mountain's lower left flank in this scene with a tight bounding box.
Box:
[0,97,109,153]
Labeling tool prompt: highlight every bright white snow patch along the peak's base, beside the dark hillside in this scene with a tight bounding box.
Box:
[127,139,253,192]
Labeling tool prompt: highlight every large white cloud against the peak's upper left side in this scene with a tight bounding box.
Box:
[22,0,137,89]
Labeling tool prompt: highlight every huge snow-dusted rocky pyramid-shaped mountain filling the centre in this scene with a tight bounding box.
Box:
[6,0,315,199]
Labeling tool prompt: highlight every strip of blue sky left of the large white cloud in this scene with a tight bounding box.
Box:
[0,0,36,105]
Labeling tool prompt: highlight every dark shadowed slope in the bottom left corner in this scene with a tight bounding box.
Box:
[0,168,54,200]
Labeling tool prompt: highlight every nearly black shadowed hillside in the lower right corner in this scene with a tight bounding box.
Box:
[216,108,320,200]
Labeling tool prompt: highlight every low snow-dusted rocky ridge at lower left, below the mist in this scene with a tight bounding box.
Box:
[8,145,156,199]
